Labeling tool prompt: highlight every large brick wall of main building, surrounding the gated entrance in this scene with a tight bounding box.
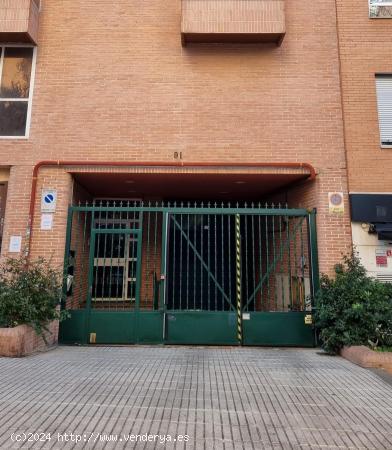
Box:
[0,0,348,270]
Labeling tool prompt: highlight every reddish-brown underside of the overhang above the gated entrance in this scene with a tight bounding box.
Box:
[70,167,310,201]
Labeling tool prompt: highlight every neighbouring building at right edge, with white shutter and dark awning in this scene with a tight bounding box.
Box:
[336,0,392,282]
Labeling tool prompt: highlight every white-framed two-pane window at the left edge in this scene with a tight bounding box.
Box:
[0,46,35,138]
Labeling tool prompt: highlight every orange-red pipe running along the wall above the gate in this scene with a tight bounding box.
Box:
[28,160,316,254]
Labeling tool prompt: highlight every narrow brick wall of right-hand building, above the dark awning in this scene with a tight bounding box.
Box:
[336,0,392,192]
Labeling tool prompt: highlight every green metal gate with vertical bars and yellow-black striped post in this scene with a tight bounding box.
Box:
[60,201,318,346]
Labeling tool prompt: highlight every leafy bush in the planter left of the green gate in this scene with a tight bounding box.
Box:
[0,258,66,336]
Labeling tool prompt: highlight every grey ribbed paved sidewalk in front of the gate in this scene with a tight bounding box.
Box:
[0,347,392,450]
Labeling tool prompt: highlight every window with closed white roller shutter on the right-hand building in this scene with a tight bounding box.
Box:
[376,75,392,148]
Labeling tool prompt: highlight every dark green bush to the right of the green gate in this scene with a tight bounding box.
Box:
[315,253,392,354]
